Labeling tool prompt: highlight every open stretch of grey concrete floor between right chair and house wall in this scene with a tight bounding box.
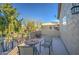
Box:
[52,38,68,55]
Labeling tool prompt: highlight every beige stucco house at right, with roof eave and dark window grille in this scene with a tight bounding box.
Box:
[58,3,79,54]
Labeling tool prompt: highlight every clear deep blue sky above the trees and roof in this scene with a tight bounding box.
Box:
[13,3,58,22]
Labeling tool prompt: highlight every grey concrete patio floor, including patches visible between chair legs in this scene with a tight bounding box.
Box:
[37,37,68,55]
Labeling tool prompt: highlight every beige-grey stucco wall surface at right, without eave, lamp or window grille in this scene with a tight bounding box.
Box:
[60,4,79,54]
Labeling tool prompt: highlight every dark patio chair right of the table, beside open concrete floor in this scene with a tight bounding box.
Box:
[40,37,52,55]
